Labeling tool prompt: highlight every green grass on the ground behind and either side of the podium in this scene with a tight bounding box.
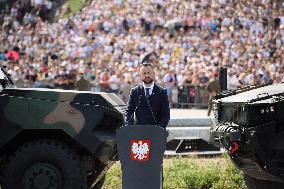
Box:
[103,154,246,189]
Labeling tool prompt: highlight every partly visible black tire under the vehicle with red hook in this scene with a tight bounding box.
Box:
[244,174,284,189]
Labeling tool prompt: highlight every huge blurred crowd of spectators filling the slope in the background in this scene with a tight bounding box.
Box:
[0,0,284,103]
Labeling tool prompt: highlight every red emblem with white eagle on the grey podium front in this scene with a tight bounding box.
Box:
[130,140,151,161]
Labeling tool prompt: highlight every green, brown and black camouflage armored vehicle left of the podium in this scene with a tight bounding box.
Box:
[0,68,125,189]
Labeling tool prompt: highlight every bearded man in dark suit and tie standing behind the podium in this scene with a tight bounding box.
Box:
[126,63,170,129]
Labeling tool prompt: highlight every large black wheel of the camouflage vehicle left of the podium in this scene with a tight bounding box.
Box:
[2,140,87,189]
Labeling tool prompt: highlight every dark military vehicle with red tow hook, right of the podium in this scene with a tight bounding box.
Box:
[210,83,284,189]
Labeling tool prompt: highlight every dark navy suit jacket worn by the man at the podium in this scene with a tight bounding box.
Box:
[126,84,170,128]
